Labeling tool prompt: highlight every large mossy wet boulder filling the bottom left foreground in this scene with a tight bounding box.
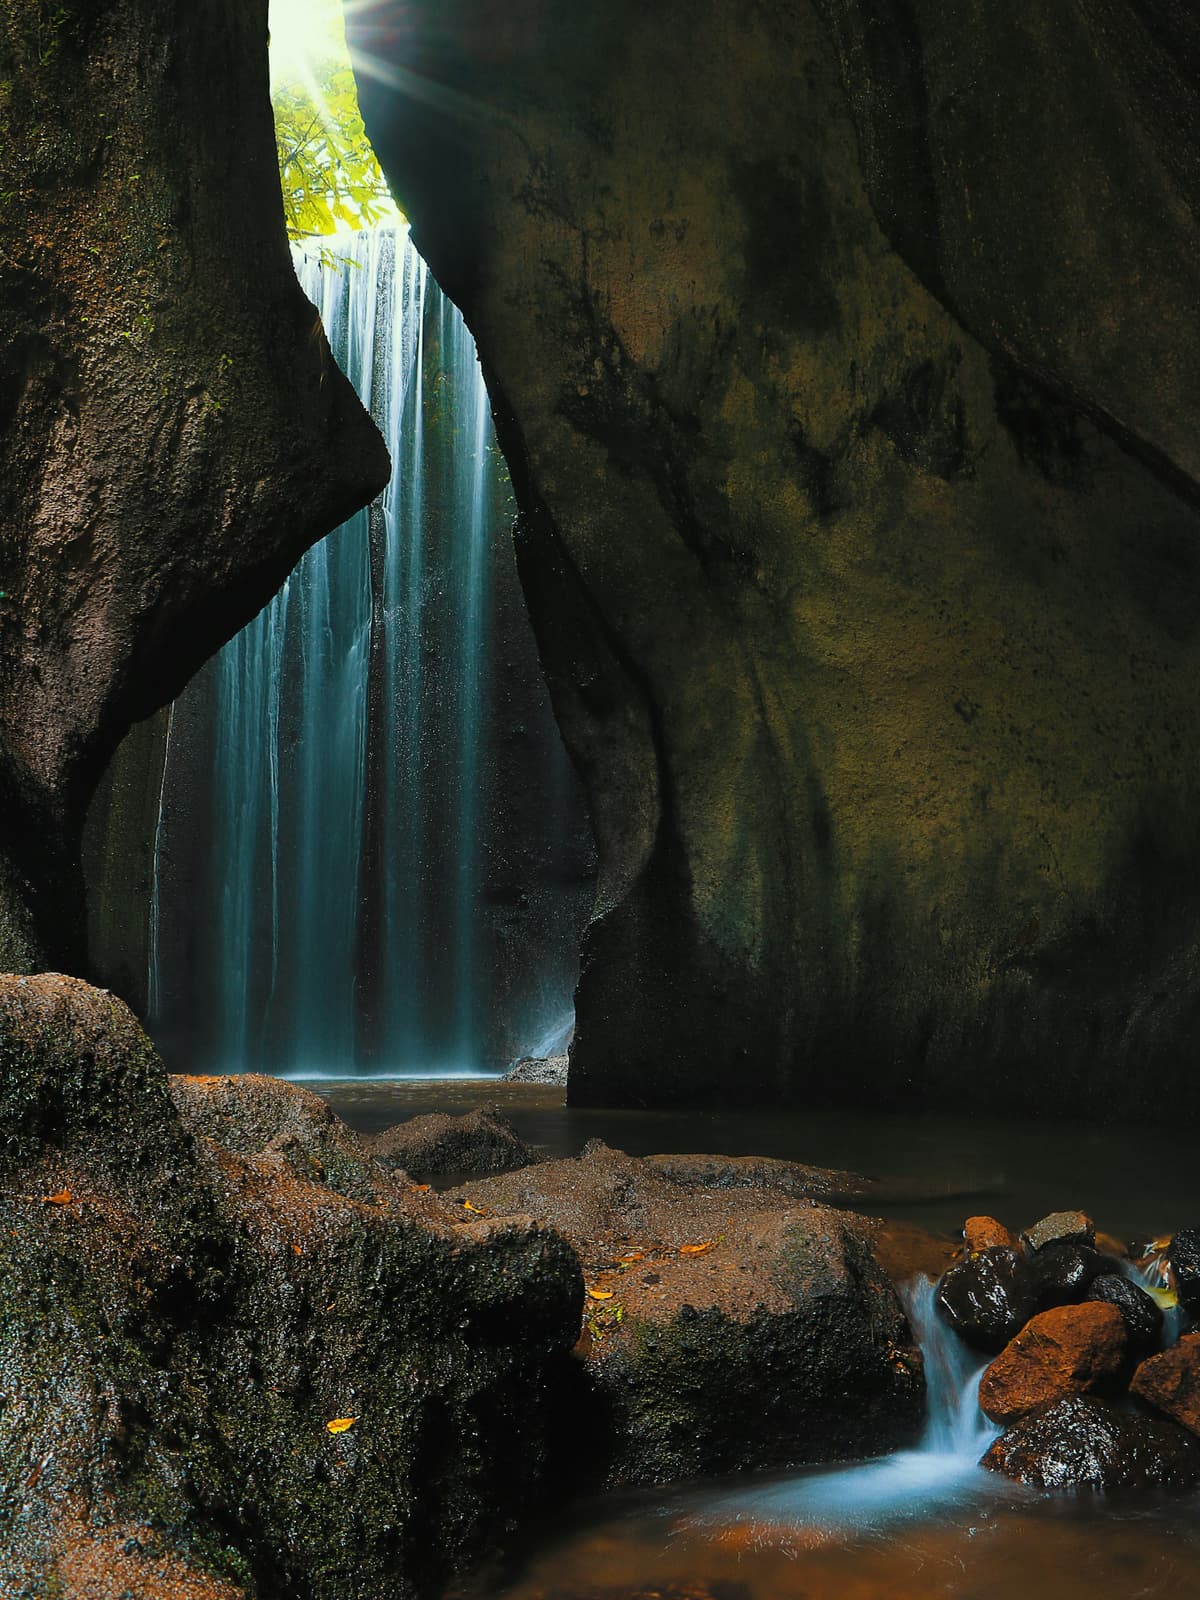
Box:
[0,976,581,1600]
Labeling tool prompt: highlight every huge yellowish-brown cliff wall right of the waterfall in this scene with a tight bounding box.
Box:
[350,0,1200,1115]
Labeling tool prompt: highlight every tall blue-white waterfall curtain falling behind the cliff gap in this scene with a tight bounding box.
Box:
[149,227,592,1077]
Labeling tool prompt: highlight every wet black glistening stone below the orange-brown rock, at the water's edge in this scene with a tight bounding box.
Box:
[982,1395,1200,1490]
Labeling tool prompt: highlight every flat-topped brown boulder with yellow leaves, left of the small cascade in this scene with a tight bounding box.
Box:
[443,1142,923,1485]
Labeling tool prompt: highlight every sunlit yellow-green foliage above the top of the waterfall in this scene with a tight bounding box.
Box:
[272,19,398,259]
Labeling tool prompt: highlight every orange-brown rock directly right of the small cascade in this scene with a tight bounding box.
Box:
[979,1302,1130,1422]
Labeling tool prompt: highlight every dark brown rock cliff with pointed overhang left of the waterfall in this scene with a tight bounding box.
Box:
[0,0,387,971]
